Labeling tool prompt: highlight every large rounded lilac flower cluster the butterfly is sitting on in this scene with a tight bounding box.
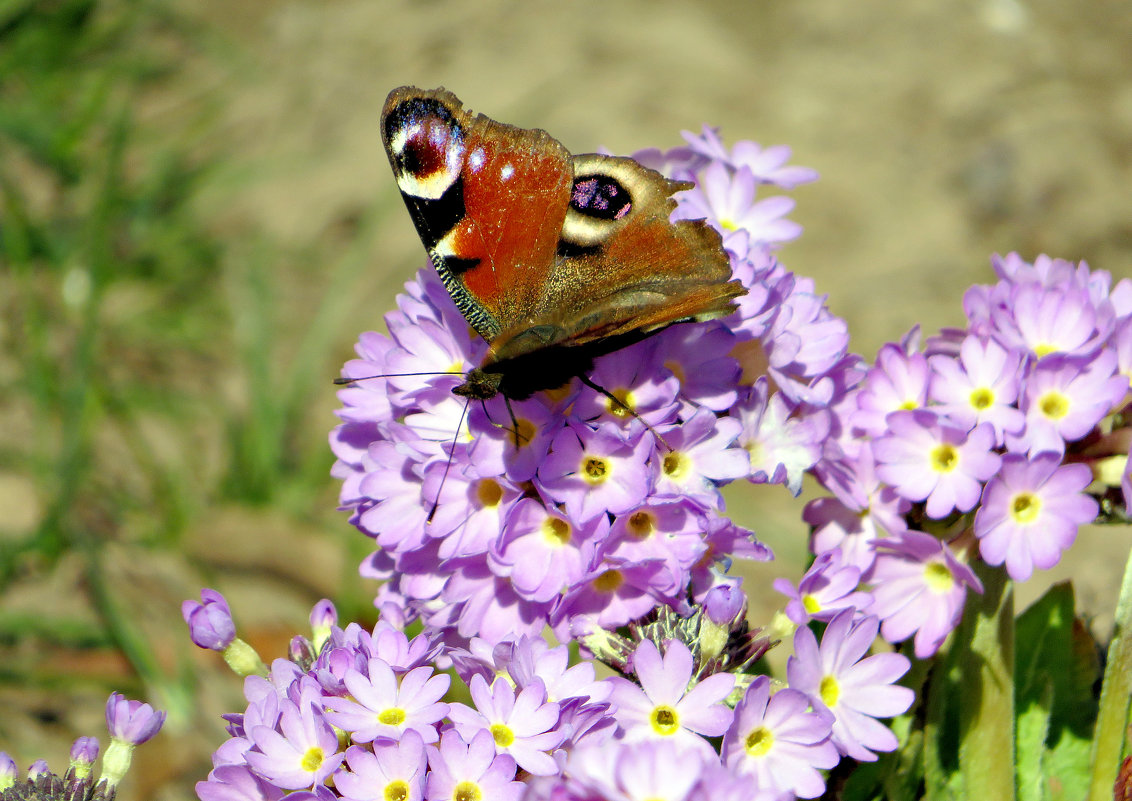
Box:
[331,129,857,645]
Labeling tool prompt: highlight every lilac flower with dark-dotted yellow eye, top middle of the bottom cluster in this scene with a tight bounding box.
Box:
[610,640,735,753]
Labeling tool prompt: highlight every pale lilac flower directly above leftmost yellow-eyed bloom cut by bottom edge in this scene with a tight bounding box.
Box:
[324,658,452,742]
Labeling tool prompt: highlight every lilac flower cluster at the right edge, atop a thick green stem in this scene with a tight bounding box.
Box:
[801,253,1132,657]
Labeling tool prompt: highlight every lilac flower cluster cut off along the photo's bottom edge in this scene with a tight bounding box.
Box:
[197,597,912,801]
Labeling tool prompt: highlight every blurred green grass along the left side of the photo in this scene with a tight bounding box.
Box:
[0,0,377,777]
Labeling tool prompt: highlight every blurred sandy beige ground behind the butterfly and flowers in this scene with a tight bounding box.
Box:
[2,0,1132,801]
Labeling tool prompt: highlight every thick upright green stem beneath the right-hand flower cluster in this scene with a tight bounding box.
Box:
[952,562,1014,801]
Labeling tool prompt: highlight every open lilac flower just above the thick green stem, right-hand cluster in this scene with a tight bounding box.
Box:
[975,453,1098,582]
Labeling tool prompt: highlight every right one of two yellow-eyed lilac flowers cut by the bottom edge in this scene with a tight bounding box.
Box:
[426,730,523,801]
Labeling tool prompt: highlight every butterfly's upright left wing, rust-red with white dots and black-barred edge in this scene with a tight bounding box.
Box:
[381,86,574,342]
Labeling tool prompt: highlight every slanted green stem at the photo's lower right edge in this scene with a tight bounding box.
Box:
[1087,545,1132,801]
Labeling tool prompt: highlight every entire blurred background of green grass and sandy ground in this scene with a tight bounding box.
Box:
[0,0,1132,800]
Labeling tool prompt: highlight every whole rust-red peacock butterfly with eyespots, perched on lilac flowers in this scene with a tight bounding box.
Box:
[381,86,746,407]
